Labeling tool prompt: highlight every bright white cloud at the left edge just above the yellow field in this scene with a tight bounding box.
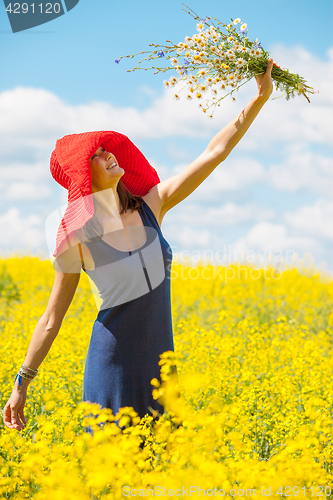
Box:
[0,208,45,249]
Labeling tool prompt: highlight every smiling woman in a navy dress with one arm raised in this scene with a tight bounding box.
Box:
[3,59,273,431]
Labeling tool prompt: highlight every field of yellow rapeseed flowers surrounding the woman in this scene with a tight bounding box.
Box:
[0,257,333,500]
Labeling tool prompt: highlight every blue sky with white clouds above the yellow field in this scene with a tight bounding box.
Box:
[0,0,333,278]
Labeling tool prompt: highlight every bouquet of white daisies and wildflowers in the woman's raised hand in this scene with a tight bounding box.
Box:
[115,4,315,117]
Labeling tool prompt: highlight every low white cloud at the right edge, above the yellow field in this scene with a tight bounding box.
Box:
[283,199,333,240]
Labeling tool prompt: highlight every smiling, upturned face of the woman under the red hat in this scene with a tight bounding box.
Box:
[89,146,125,192]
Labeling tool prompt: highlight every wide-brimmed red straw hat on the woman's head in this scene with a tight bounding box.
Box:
[50,131,160,257]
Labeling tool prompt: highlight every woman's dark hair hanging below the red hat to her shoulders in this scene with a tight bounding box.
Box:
[76,179,142,243]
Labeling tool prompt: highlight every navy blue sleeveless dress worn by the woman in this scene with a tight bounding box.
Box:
[83,200,174,417]
